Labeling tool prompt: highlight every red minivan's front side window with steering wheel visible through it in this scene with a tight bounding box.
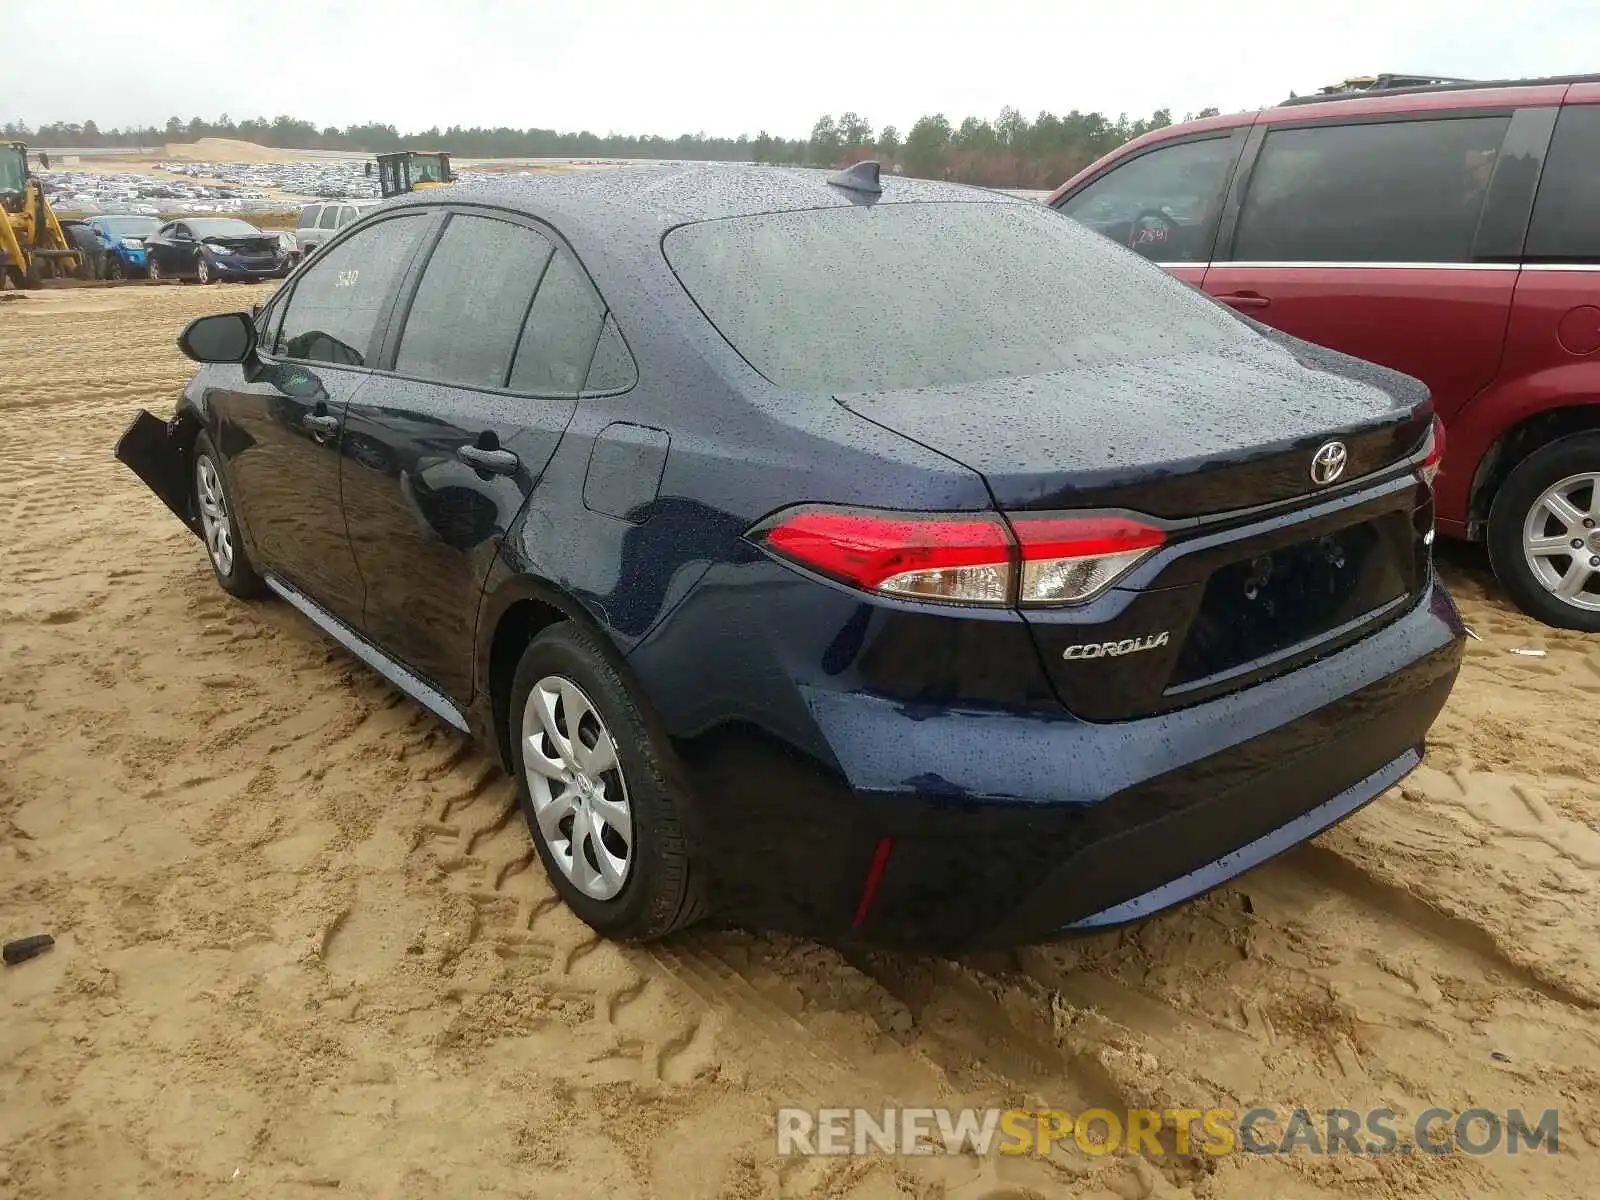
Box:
[1059,134,1238,262]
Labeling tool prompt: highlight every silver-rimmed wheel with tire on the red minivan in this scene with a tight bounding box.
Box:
[1488,434,1600,632]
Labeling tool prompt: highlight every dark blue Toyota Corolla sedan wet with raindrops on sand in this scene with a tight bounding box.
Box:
[117,163,1462,949]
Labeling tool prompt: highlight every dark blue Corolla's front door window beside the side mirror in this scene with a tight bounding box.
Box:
[274,213,427,366]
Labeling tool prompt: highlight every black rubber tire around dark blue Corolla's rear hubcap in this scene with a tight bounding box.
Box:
[507,622,706,941]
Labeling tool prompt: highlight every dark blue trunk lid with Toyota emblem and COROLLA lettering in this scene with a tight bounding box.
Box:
[837,339,1432,720]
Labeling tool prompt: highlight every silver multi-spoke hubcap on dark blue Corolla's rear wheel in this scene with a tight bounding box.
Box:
[522,675,634,899]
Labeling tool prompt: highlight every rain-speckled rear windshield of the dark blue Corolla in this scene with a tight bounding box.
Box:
[664,203,1251,392]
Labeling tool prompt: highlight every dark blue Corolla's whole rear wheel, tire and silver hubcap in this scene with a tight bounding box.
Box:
[507,622,704,941]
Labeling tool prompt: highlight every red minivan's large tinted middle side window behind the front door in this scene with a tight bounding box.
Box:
[1234,117,1510,262]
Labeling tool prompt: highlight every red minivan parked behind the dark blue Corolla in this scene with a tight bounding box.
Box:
[1048,75,1600,630]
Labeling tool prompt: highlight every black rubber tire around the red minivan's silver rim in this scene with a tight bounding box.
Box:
[1488,432,1600,634]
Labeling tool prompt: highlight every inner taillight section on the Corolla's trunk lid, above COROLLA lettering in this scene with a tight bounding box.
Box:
[1011,514,1166,605]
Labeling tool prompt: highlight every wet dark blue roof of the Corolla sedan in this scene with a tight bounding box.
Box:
[380,163,1029,235]
